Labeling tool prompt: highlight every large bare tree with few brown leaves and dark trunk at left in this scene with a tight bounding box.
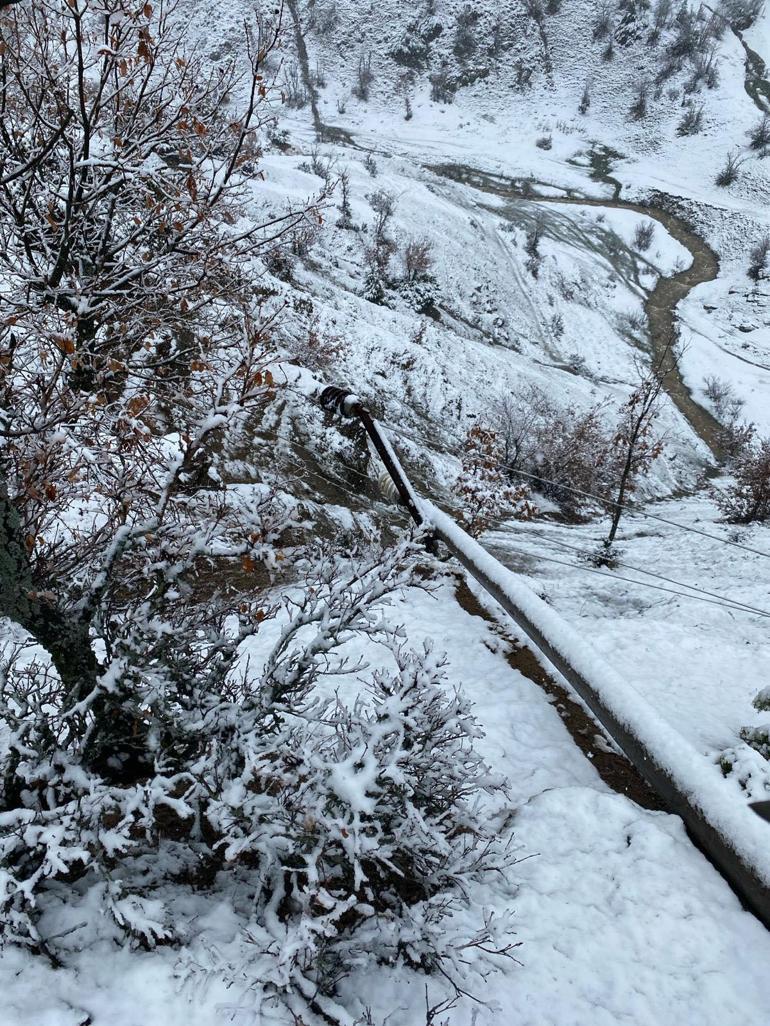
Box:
[0,0,322,783]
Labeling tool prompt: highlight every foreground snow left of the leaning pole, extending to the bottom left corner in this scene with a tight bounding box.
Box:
[6,580,770,1026]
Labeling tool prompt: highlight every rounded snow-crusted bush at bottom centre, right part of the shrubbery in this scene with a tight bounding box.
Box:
[208,567,513,991]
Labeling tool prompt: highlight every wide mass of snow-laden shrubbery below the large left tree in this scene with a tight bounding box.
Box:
[0,529,519,1009]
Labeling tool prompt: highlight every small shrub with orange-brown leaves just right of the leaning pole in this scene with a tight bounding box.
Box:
[452,425,536,538]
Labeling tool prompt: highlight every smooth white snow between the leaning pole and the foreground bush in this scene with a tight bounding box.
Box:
[332,588,770,1026]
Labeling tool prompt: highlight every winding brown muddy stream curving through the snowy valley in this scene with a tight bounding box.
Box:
[428,163,722,461]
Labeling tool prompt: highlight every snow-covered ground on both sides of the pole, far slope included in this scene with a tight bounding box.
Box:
[0,0,770,1026]
